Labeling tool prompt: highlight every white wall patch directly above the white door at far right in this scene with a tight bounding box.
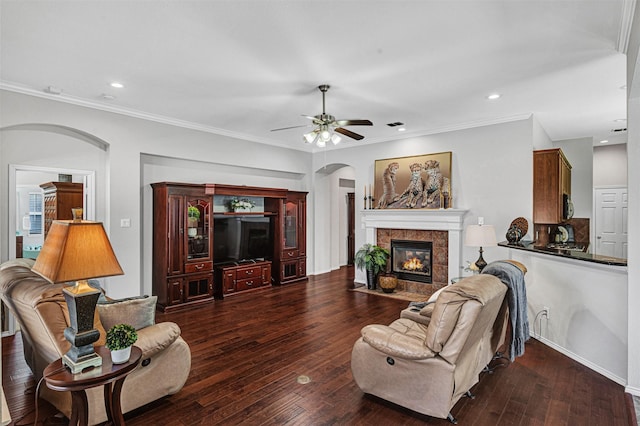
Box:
[593,143,627,188]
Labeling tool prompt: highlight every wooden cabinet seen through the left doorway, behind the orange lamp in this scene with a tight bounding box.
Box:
[40,182,83,238]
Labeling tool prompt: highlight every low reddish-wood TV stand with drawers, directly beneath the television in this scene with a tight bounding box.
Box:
[216,261,271,295]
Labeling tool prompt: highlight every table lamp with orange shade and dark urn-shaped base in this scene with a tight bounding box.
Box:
[33,220,124,374]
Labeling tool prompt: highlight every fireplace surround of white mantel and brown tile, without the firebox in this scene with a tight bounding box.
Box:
[362,209,467,295]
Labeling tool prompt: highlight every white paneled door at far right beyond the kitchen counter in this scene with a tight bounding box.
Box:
[592,187,627,259]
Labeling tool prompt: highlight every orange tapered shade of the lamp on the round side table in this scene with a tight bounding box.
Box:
[33,220,124,283]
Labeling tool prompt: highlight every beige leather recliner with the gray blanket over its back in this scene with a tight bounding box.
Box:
[351,275,508,423]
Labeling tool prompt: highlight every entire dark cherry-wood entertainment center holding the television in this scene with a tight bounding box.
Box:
[151,182,307,311]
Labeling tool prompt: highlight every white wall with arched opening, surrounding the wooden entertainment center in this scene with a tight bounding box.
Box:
[0,91,314,298]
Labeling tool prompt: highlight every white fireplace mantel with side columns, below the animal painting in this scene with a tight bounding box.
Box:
[361,209,469,280]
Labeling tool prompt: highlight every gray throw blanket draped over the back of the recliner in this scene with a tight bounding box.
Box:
[482,261,529,361]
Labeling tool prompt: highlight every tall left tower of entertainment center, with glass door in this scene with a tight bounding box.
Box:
[151,182,214,311]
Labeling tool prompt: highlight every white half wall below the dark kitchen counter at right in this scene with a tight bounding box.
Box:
[503,249,632,385]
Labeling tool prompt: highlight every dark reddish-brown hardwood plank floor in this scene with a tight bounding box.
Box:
[2,268,631,426]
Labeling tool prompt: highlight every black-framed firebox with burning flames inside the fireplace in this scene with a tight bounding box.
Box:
[391,240,433,283]
